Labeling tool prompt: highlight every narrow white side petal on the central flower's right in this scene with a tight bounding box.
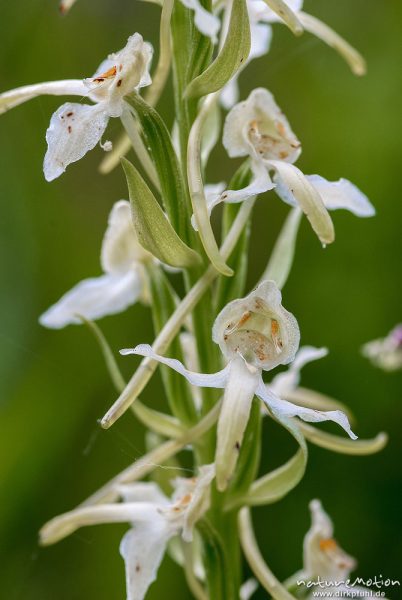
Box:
[256,379,357,440]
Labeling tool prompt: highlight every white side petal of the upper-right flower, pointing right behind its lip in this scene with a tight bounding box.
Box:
[307,175,375,217]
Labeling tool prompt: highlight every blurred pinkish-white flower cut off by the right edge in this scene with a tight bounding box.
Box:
[362,324,402,371]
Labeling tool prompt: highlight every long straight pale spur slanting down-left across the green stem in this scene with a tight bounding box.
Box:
[101,198,254,429]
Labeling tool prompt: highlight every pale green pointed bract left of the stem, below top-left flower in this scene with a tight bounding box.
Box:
[122,158,200,268]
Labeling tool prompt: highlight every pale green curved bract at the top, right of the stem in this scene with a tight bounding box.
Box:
[185,0,251,98]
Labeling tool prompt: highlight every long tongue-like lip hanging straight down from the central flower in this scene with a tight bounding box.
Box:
[215,356,261,491]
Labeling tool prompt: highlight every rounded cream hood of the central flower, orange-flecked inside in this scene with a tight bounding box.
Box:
[212,281,300,370]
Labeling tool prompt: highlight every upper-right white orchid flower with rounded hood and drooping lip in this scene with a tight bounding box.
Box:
[218,88,375,244]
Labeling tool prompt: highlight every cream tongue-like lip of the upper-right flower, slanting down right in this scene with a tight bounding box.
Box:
[266,160,335,245]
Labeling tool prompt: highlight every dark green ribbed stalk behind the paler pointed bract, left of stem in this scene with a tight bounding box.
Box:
[125,93,192,242]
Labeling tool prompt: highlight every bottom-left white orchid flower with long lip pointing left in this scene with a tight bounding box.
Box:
[40,465,215,600]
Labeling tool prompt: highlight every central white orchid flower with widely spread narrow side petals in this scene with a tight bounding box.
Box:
[121,281,356,490]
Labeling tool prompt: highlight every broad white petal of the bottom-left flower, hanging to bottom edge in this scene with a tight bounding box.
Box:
[120,519,172,600]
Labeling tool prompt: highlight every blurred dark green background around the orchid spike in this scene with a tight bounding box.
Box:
[0,0,402,600]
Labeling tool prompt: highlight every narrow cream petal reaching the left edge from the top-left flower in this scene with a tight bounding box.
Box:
[0,79,88,114]
